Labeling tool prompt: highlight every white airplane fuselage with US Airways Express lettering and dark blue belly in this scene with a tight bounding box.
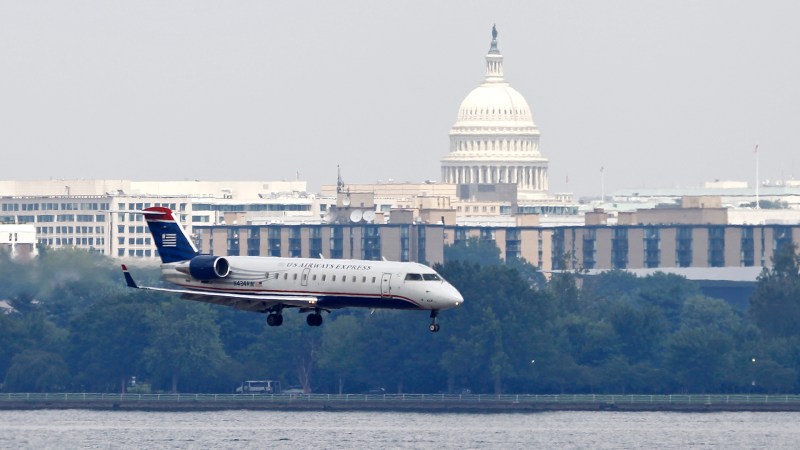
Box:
[162,256,464,310]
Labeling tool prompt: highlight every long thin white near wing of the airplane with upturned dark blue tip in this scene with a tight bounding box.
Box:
[122,264,318,312]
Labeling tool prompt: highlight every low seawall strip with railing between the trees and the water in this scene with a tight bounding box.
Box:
[0,393,800,413]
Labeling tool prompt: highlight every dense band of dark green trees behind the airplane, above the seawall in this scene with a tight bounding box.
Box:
[0,240,800,394]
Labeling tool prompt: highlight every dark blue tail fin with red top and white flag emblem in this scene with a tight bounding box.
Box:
[142,206,200,263]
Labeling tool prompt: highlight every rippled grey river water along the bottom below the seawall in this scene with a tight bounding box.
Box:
[0,410,800,450]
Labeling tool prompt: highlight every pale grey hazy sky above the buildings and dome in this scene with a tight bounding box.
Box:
[0,0,800,195]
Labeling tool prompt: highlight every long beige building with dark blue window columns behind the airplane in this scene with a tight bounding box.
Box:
[196,200,800,271]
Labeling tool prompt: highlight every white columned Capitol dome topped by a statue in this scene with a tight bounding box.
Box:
[442,27,548,200]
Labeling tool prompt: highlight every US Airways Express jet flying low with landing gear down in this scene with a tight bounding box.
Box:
[122,206,464,333]
